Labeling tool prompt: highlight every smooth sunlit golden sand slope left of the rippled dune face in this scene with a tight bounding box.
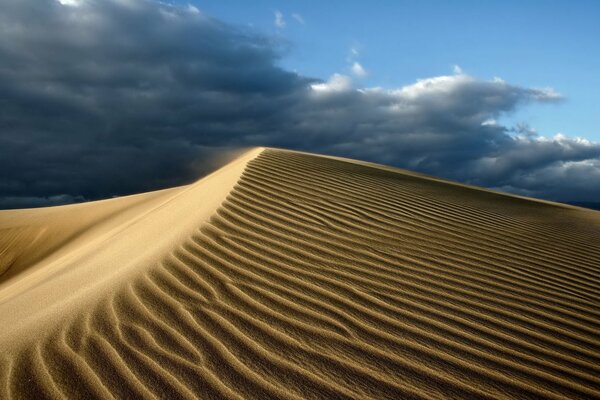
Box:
[0,148,262,346]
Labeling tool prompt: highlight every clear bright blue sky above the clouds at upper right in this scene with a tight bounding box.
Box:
[197,0,600,141]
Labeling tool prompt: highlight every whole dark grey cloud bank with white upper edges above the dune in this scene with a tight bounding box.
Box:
[0,0,600,208]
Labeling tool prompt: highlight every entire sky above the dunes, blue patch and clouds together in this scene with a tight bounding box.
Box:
[0,0,600,208]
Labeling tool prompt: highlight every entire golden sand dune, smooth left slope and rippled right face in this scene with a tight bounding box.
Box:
[0,148,600,399]
